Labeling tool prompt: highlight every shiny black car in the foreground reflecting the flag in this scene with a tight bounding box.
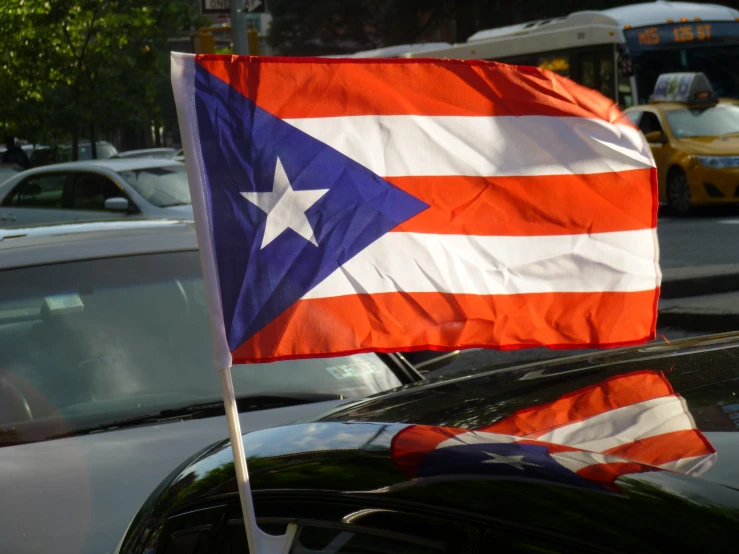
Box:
[117,333,739,554]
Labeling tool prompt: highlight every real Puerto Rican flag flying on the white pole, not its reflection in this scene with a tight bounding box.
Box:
[172,54,660,365]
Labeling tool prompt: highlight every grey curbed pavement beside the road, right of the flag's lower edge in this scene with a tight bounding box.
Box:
[657,264,739,332]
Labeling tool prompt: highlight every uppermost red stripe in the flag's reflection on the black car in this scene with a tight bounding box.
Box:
[479,371,672,438]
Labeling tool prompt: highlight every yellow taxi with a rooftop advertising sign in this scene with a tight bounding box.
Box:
[625,73,739,215]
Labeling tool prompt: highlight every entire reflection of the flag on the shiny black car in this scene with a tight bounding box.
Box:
[391,371,716,489]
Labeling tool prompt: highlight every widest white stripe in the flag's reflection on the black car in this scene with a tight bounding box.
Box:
[529,396,695,452]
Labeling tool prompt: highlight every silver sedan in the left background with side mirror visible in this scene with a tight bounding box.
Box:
[0,158,192,225]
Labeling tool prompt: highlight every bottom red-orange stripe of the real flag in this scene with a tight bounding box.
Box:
[232,289,659,364]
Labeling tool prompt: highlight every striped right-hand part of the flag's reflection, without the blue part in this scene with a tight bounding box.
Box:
[483,371,716,475]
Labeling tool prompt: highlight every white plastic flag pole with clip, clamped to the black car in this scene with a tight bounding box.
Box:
[172,52,297,554]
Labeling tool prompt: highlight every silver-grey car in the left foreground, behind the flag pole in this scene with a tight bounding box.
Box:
[0,220,428,554]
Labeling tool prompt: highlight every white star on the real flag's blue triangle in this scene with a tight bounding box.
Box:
[241,158,328,250]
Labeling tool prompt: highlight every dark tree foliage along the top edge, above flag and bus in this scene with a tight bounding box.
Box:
[269,0,739,56]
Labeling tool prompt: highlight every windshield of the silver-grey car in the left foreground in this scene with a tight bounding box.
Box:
[0,251,401,441]
